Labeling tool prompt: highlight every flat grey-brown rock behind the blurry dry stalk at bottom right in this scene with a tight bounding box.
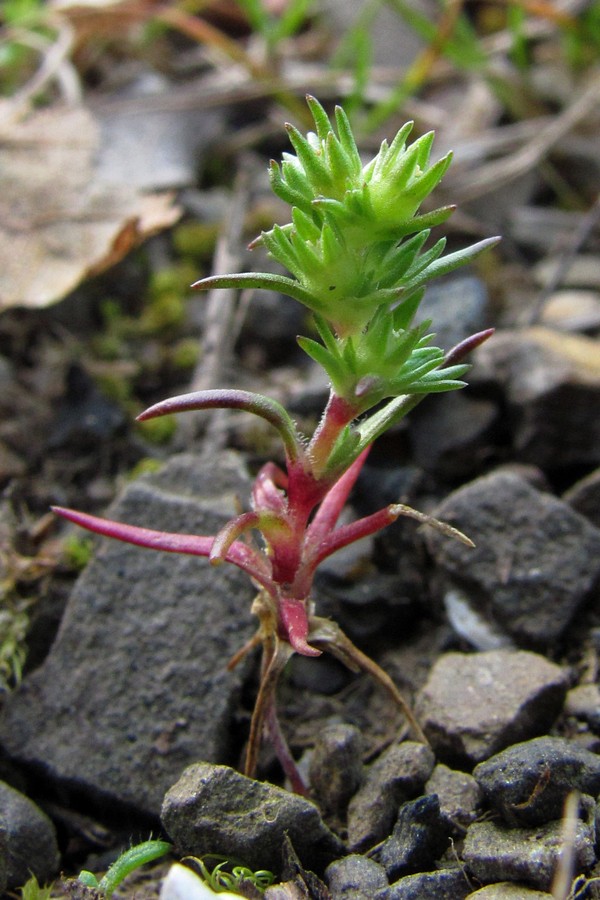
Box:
[462,820,595,891]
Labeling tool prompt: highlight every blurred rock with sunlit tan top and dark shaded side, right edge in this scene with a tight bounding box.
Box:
[470,327,600,470]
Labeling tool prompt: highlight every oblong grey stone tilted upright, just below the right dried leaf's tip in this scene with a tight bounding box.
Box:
[348,741,435,850]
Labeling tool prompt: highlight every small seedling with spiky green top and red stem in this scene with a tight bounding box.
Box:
[56,97,497,792]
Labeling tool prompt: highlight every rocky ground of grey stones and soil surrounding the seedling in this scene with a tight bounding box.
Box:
[0,3,600,900]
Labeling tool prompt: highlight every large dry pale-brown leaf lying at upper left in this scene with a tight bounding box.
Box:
[0,107,181,312]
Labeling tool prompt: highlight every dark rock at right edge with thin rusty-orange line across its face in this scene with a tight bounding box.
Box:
[473,737,600,827]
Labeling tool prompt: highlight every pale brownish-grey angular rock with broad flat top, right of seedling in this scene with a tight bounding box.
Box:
[416,649,567,766]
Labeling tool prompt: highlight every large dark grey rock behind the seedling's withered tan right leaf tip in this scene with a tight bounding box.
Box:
[427,471,600,646]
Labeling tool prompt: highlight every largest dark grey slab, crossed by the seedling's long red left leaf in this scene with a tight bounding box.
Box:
[0,454,255,816]
